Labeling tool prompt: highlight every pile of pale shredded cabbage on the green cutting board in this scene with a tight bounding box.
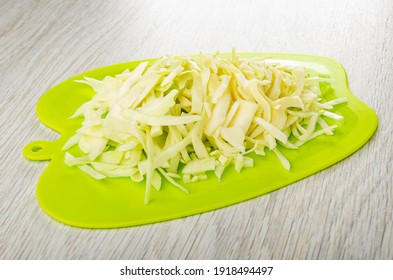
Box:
[63,52,346,203]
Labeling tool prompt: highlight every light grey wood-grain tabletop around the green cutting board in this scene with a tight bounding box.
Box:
[0,0,393,259]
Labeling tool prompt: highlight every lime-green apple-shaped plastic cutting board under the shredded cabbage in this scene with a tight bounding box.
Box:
[23,53,378,228]
